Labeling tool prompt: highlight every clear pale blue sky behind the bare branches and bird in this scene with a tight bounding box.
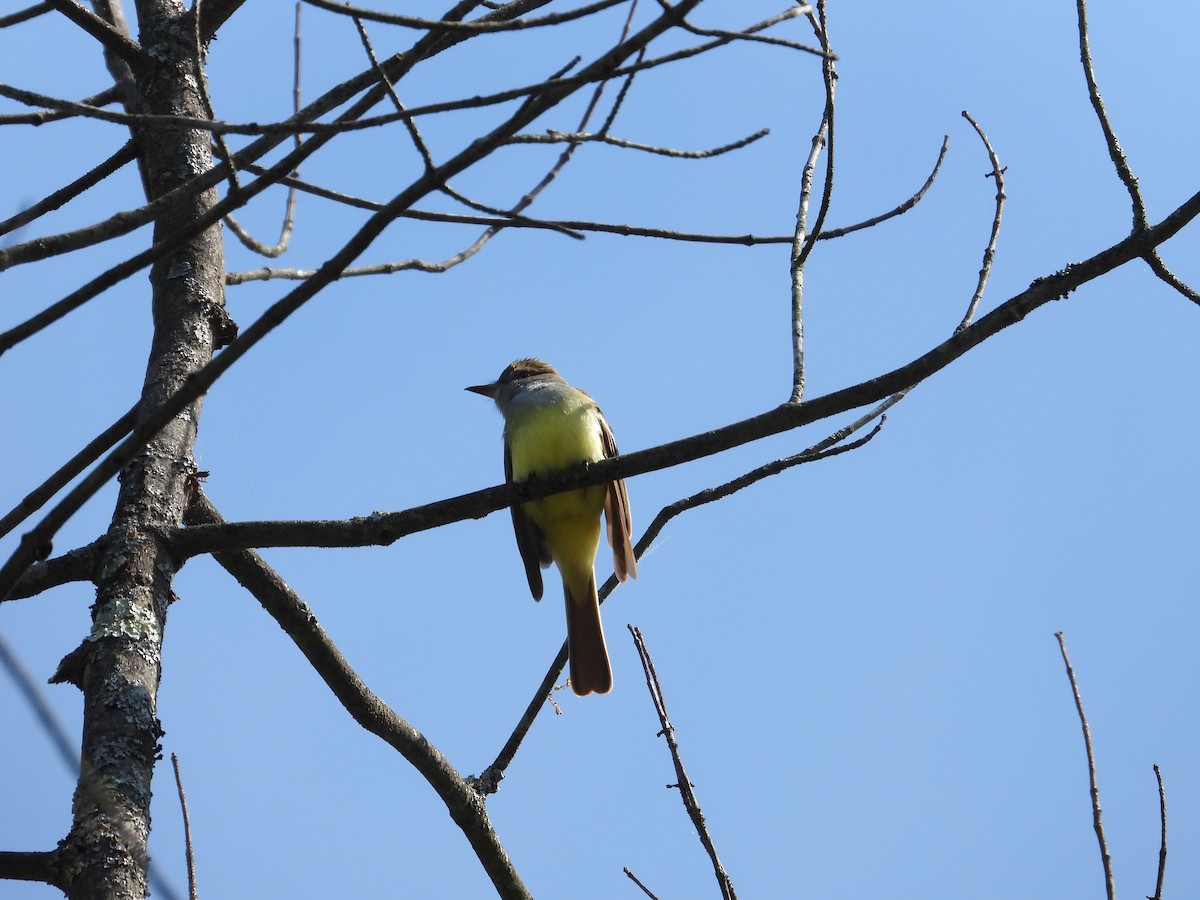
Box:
[0,0,1200,900]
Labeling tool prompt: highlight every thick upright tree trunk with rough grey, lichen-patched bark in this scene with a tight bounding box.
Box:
[65,0,224,900]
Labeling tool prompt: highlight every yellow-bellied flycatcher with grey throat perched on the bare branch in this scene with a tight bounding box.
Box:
[467,359,637,696]
